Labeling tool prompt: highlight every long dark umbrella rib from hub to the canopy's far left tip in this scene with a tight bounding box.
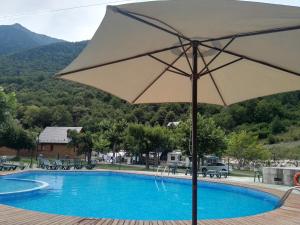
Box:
[56,43,190,76]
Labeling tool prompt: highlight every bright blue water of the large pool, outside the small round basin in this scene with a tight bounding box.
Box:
[0,171,279,220]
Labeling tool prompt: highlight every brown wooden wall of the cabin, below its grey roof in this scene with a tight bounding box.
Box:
[37,144,77,158]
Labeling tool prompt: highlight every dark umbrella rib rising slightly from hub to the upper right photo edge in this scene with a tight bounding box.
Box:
[200,25,300,43]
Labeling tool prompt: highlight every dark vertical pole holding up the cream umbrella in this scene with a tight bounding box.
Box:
[192,41,198,225]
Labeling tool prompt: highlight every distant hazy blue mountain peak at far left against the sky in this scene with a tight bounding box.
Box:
[0,23,63,55]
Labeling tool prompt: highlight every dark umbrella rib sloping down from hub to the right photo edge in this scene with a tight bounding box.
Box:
[199,43,300,76]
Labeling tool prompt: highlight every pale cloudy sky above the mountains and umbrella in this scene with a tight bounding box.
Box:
[0,0,300,41]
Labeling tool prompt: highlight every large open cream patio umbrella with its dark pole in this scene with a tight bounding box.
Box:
[58,0,300,225]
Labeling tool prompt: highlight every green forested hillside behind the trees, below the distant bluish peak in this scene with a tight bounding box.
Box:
[0,24,300,143]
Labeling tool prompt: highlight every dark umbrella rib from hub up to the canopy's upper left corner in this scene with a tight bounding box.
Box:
[110,6,191,41]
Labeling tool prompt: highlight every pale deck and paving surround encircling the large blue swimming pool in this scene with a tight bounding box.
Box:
[0,169,300,225]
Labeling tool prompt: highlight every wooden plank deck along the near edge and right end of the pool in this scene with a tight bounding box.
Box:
[0,171,300,225]
